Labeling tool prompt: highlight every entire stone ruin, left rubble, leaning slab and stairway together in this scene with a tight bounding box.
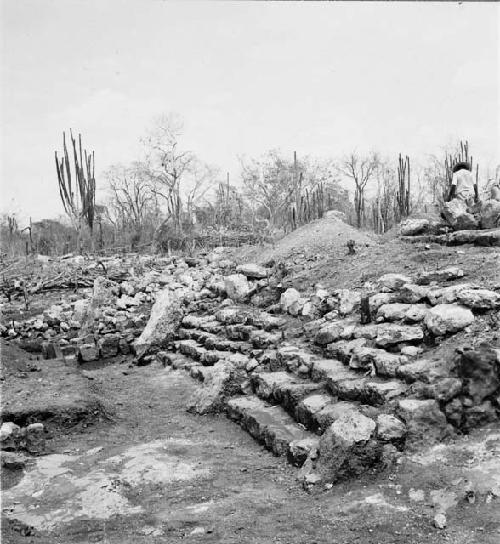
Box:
[1,248,500,485]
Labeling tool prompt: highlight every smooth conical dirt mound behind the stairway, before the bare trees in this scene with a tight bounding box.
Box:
[242,212,377,262]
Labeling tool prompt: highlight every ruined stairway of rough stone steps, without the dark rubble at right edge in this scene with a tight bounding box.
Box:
[159,268,500,484]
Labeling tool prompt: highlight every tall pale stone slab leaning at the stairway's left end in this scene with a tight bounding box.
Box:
[134,288,184,358]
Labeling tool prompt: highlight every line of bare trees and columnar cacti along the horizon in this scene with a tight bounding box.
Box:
[0,111,498,255]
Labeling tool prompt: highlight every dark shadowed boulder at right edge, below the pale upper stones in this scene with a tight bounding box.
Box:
[458,343,500,405]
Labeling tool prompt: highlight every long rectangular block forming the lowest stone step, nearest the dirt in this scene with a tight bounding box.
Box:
[226,396,319,466]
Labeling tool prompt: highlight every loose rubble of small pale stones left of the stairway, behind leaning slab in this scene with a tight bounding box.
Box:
[0,249,258,362]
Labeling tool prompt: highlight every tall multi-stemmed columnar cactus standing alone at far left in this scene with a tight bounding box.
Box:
[55,131,95,252]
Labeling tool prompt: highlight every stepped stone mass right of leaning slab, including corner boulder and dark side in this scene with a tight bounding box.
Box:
[157,265,500,483]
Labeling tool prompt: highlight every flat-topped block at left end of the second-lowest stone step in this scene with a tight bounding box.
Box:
[252,371,325,416]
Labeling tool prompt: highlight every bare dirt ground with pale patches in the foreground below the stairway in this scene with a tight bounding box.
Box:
[2,356,500,544]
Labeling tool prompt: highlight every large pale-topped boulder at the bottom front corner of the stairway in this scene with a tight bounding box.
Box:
[317,410,381,481]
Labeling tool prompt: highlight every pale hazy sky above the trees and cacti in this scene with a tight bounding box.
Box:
[0,0,500,220]
